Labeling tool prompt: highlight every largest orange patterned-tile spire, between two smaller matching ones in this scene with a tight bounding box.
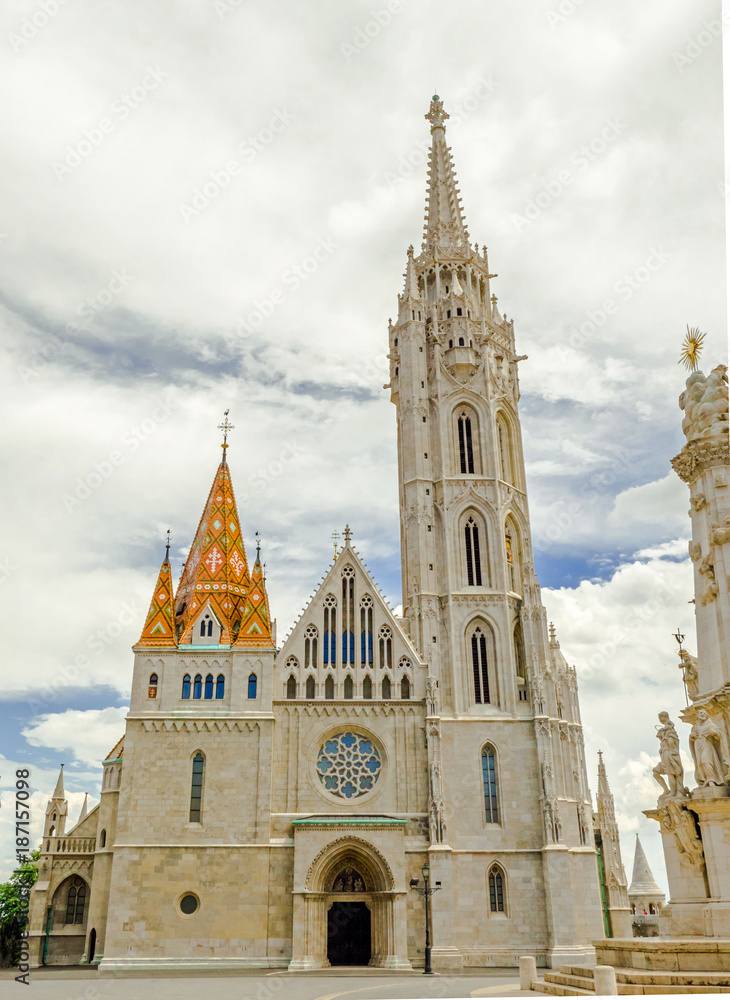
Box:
[175,450,251,645]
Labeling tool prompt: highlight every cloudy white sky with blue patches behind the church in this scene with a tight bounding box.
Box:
[0,0,727,892]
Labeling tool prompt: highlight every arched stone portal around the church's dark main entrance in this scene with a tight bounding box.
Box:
[290,836,410,969]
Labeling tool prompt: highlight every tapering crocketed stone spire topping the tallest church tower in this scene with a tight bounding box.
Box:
[423,94,469,252]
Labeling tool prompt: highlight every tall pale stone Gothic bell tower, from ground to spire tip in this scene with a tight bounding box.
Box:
[388,96,602,968]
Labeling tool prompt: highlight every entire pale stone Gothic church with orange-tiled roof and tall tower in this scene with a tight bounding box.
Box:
[30,96,603,972]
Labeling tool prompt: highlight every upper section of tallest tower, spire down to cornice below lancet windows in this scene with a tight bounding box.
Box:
[389,96,536,716]
